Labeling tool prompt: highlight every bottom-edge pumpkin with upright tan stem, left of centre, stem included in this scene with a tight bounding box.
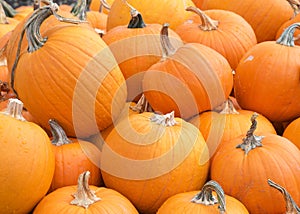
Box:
[33,171,138,214]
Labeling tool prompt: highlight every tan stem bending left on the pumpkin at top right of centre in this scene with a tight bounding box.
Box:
[185,6,219,31]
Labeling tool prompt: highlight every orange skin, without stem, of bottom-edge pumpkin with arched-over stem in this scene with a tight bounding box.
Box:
[157,191,249,214]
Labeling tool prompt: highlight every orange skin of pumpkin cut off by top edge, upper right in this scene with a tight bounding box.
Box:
[202,0,294,43]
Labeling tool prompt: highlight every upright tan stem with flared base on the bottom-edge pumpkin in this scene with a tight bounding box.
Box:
[71,171,101,209]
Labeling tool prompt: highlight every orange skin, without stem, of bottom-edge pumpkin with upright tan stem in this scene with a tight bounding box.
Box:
[33,185,138,214]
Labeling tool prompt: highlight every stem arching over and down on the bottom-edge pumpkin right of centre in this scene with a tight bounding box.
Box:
[191,180,226,213]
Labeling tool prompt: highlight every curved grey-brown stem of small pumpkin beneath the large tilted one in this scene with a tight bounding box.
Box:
[48,119,72,146]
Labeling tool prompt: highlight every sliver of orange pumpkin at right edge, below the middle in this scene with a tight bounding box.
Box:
[282,117,300,149]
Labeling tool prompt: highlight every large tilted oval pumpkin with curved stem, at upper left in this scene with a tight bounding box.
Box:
[7,5,127,138]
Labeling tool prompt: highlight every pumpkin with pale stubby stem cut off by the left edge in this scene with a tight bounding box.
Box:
[0,99,54,213]
